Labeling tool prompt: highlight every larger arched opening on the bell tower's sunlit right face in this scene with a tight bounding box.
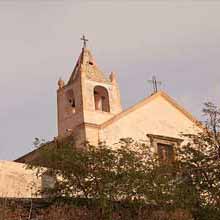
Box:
[94,86,110,112]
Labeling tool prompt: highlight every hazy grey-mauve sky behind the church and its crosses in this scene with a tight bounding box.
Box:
[0,0,220,160]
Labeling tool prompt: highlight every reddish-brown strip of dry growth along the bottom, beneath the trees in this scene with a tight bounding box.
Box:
[0,199,192,220]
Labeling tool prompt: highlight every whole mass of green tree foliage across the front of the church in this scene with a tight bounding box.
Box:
[29,103,220,220]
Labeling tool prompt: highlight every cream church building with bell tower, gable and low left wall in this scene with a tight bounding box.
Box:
[0,41,201,197]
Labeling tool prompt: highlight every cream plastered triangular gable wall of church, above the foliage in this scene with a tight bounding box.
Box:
[100,92,200,144]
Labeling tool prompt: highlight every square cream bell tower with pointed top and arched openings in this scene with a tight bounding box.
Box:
[57,36,122,143]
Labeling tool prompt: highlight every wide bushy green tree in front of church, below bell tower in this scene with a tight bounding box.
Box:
[28,138,182,216]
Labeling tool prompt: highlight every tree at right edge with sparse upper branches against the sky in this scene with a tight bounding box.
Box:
[171,102,220,219]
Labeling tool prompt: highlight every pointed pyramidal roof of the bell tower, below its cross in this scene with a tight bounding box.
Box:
[67,48,110,84]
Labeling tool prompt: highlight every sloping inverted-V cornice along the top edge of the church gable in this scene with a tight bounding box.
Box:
[100,91,203,128]
